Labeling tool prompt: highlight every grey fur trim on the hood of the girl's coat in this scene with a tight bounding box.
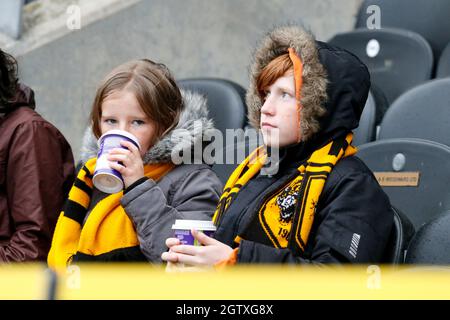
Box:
[80,90,214,164]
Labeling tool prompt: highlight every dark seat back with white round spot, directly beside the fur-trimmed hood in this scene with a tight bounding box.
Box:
[329,29,433,104]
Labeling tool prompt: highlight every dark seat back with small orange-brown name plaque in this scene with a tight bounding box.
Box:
[356,139,450,230]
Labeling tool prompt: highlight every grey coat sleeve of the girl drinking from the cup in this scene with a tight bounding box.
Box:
[121,168,222,263]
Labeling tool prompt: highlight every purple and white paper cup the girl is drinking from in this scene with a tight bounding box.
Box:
[92,130,140,193]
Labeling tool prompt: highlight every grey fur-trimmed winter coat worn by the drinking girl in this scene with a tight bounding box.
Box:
[81,91,223,262]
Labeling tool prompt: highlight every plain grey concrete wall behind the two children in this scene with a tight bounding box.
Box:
[0,0,362,160]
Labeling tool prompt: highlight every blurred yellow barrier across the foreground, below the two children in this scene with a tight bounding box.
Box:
[48,264,450,298]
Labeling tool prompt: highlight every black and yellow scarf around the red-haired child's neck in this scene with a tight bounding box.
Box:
[213,133,357,254]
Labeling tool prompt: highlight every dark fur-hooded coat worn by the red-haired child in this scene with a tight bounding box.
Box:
[215,26,393,264]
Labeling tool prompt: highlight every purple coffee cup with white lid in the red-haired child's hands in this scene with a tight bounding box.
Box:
[172,220,216,246]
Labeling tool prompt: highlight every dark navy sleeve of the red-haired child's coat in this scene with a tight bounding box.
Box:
[238,161,393,264]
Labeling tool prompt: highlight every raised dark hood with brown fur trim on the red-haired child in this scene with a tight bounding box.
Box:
[246,25,370,142]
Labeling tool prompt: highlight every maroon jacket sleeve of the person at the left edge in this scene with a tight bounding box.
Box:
[0,121,74,262]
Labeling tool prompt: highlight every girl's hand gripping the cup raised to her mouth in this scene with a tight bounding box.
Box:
[108,140,144,188]
